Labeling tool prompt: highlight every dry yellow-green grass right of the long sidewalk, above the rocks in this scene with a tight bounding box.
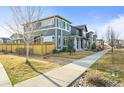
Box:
[87,49,124,82]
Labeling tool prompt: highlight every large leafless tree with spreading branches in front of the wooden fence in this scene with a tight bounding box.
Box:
[2,6,44,63]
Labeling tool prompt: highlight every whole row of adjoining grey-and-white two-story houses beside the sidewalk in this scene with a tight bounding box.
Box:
[21,15,97,51]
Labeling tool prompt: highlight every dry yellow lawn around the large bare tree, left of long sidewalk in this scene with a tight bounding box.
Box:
[0,55,62,85]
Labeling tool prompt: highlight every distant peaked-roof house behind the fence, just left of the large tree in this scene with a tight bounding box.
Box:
[10,33,24,44]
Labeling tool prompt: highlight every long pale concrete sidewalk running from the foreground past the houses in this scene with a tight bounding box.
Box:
[15,50,108,87]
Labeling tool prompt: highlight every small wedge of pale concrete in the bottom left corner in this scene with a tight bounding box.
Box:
[0,63,12,87]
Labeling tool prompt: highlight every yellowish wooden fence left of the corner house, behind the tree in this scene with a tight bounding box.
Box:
[0,43,55,55]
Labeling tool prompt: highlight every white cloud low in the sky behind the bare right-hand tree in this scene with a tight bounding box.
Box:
[98,15,124,39]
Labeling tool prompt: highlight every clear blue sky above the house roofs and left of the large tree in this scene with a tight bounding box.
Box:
[0,6,124,38]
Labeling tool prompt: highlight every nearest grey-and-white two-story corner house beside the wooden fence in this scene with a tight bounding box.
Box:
[24,15,71,49]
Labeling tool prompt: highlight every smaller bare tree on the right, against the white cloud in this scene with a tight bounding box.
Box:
[106,26,119,53]
